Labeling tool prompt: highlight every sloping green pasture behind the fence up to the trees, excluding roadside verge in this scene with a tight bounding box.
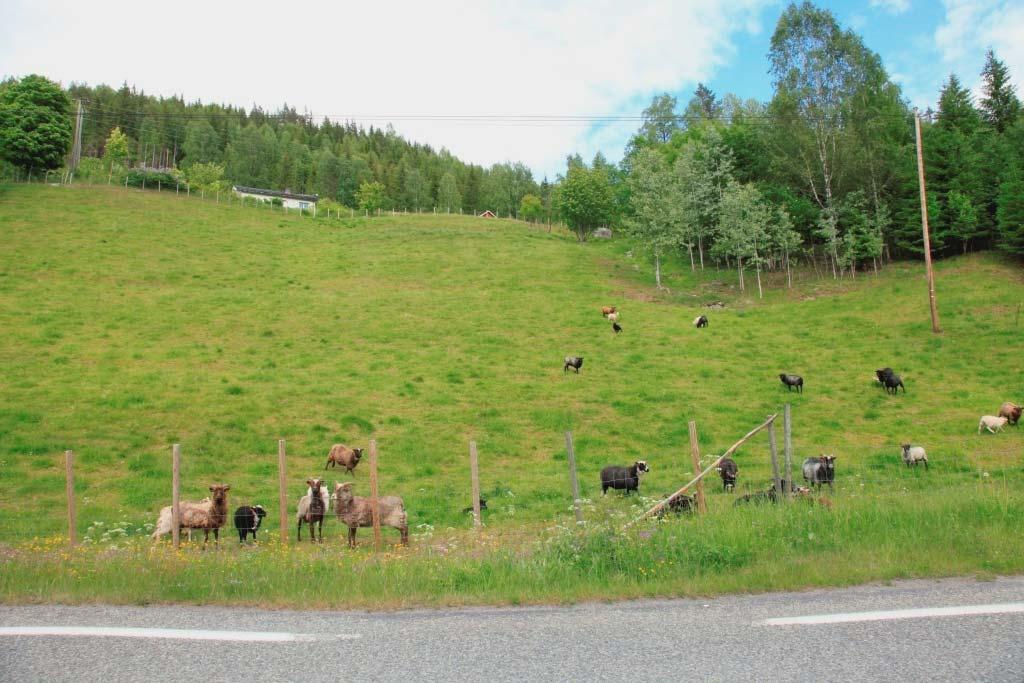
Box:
[0,186,1024,606]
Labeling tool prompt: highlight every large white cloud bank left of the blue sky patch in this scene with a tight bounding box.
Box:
[0,0,767,180]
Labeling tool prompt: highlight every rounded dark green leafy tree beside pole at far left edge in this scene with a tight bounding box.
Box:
[0,75,72,174]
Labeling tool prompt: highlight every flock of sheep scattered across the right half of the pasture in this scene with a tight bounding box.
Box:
[577,306,1024,512]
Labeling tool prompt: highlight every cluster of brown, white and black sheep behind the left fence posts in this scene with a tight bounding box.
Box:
[153,443,409,547]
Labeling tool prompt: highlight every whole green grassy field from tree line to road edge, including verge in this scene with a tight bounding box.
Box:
[0,186,1024,606]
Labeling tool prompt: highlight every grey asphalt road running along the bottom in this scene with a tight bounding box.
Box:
[0,577,1024,683]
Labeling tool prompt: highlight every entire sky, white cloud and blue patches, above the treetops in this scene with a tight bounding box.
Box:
[0,0,1024,180]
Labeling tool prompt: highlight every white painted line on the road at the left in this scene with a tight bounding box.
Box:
[0,626,361,643]
